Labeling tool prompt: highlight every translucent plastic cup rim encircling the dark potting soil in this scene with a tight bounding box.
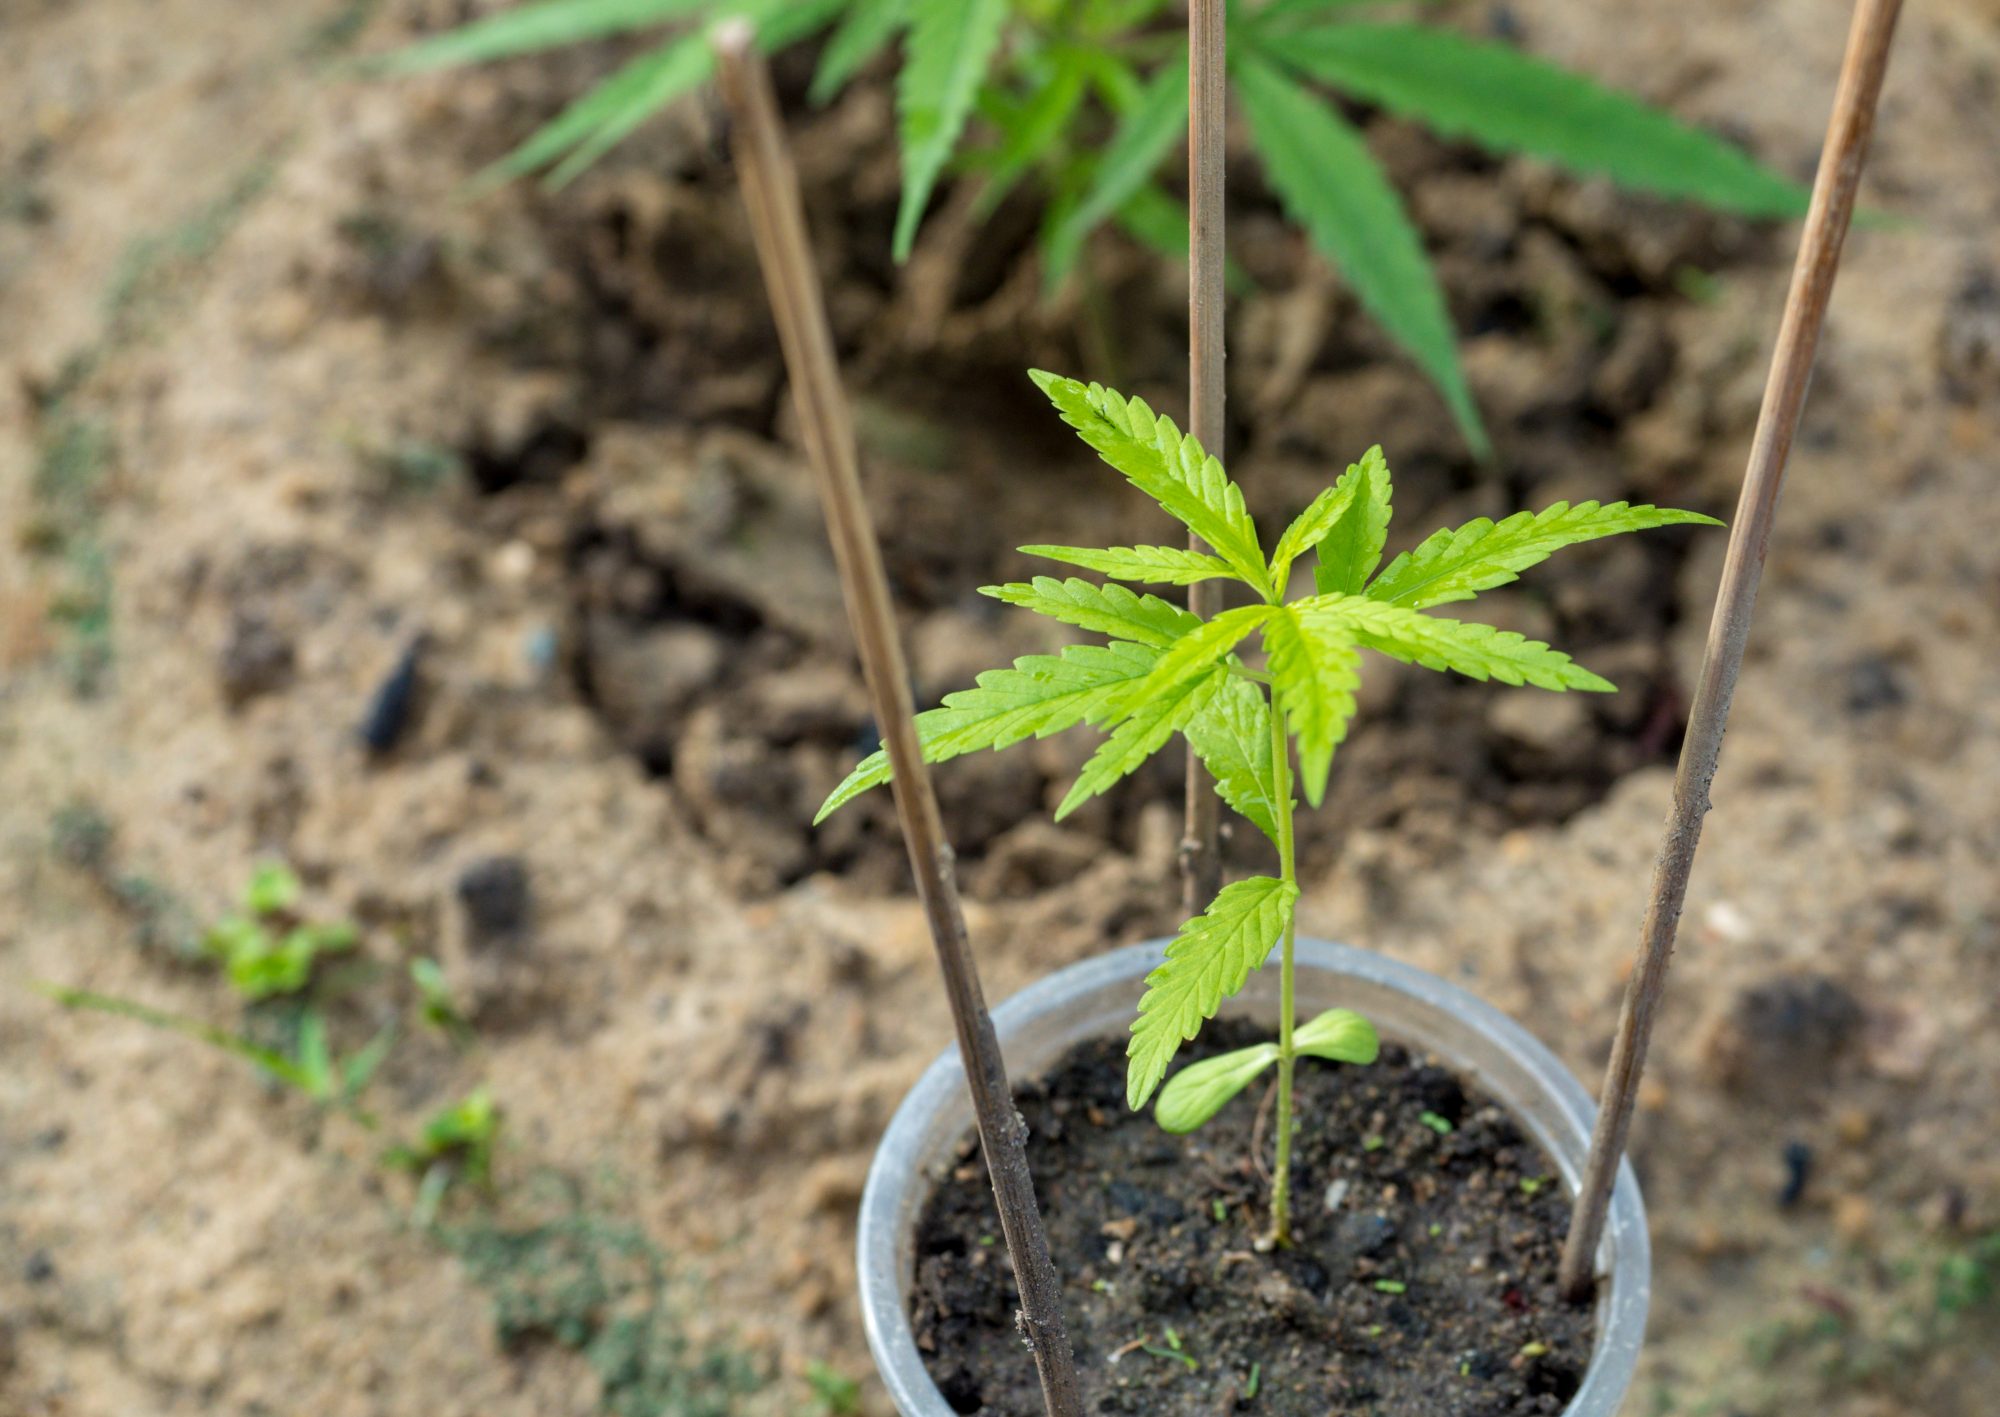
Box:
[858,939,1652,1417]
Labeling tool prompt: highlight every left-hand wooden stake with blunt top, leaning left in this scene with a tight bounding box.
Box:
[714,22,1082,1417]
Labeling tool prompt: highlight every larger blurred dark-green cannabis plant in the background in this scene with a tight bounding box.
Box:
[388,0,1806,452]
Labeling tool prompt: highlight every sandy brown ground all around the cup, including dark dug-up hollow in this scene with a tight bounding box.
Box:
[0,0,2000,1417]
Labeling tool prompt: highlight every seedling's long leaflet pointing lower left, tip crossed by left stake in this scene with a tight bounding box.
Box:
[812,640,1160,827]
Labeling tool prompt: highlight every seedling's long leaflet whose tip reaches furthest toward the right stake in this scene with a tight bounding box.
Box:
[1368,502,1722,610]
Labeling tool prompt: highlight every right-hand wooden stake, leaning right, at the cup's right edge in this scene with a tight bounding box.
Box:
[1558,0,1902,1301]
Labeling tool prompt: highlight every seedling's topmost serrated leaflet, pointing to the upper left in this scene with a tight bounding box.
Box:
[1028,368,1266,586]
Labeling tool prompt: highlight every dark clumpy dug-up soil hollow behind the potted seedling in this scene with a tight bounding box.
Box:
[414,66,1764,893]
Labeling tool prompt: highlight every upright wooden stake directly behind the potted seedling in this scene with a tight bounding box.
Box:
[1180,0,1228,917]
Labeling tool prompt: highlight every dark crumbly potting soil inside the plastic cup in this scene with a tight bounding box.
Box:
[910,1021,1596,1417]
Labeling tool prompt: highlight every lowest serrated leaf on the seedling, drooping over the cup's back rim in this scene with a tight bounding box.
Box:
[1126,877,1298,1111]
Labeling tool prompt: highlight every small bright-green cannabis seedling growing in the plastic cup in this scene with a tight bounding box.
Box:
[820,372,1718,1243]
